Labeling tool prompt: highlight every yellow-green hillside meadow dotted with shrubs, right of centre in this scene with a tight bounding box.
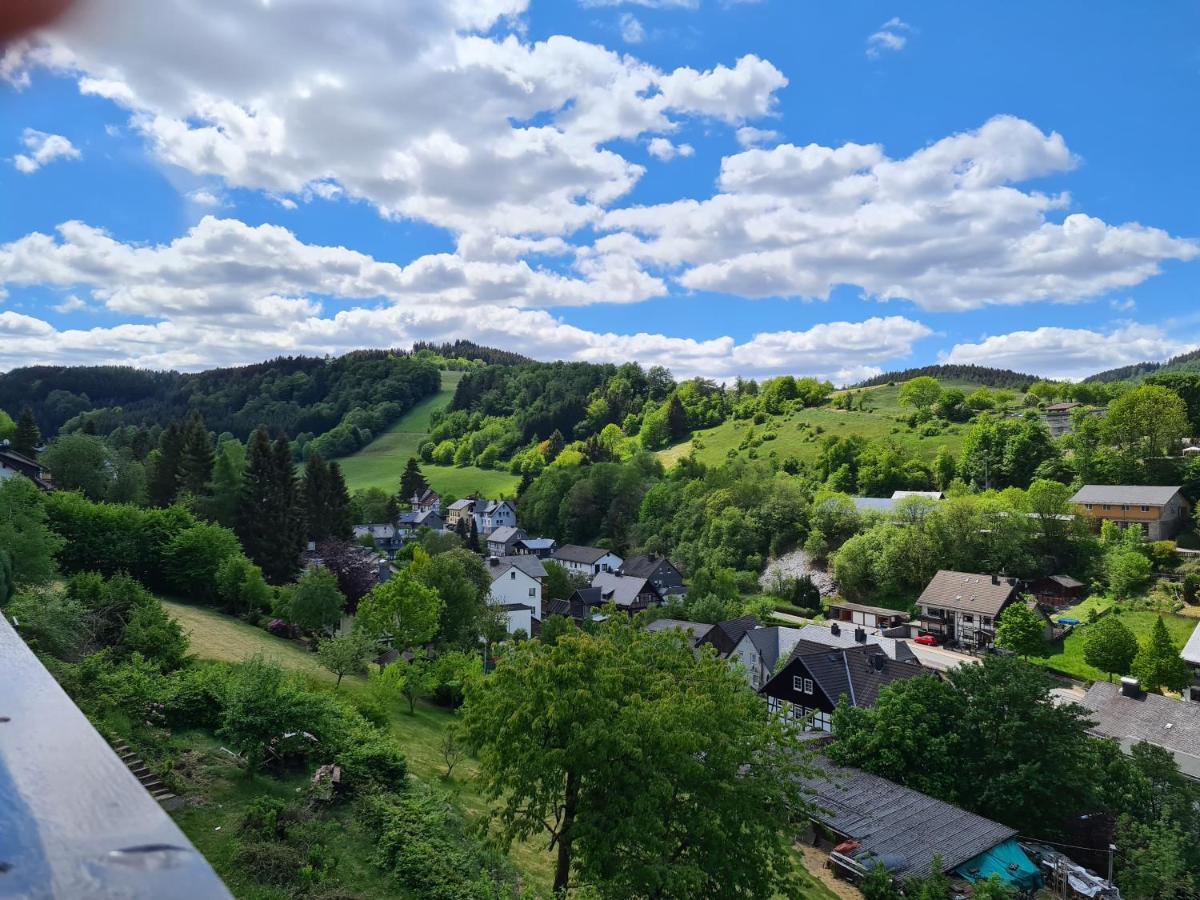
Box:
[659,379,979,466]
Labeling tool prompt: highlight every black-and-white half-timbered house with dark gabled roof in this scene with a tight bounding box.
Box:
[758,641,925,731]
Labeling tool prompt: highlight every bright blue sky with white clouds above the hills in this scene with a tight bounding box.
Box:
[0,0,1200,383]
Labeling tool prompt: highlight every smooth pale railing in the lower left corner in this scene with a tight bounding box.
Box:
[0,614,230,900]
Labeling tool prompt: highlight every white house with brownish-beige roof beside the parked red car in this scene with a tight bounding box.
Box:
[917,569,1020,649]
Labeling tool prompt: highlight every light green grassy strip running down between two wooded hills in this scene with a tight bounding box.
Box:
[337,372,520,497]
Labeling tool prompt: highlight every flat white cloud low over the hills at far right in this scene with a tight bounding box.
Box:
[941,324,1194,379]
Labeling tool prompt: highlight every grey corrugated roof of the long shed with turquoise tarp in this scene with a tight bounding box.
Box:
[802,758,1016,875]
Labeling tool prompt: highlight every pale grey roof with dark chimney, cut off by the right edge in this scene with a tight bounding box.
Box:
[1079,682,1200,778]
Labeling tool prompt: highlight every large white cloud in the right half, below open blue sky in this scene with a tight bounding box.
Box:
[588,116,1200,310]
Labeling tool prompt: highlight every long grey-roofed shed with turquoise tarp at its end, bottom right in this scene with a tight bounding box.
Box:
[800,757,1043,896]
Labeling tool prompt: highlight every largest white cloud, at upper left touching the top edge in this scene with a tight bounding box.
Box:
[9,0,786,241]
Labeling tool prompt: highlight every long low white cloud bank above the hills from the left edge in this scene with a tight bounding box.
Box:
[0,217,931,380]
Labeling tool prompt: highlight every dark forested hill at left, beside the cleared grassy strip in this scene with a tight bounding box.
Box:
[0,350,439,456]
